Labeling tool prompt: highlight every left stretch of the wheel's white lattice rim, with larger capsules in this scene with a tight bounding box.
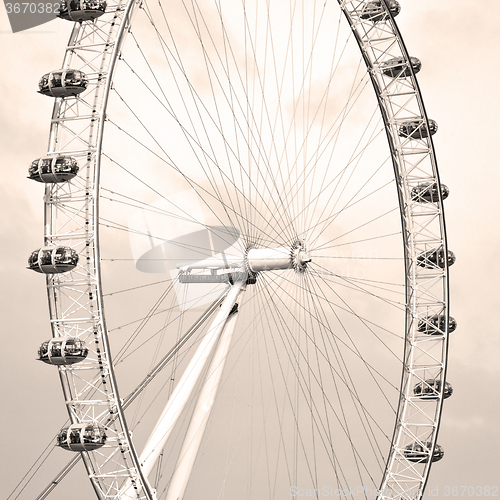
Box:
[45,2,153,500]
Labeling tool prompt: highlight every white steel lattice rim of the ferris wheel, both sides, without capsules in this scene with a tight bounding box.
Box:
[38,0,448,500]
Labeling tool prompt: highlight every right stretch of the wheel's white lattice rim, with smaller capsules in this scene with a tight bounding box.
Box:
[339,0,449,499]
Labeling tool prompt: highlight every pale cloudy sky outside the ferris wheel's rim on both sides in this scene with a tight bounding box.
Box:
[0,0,500,498]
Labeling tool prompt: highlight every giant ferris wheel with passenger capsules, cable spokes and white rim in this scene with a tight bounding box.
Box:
[29,0,456,500]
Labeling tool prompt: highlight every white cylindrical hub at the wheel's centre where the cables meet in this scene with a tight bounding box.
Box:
[246,241,311,273]
